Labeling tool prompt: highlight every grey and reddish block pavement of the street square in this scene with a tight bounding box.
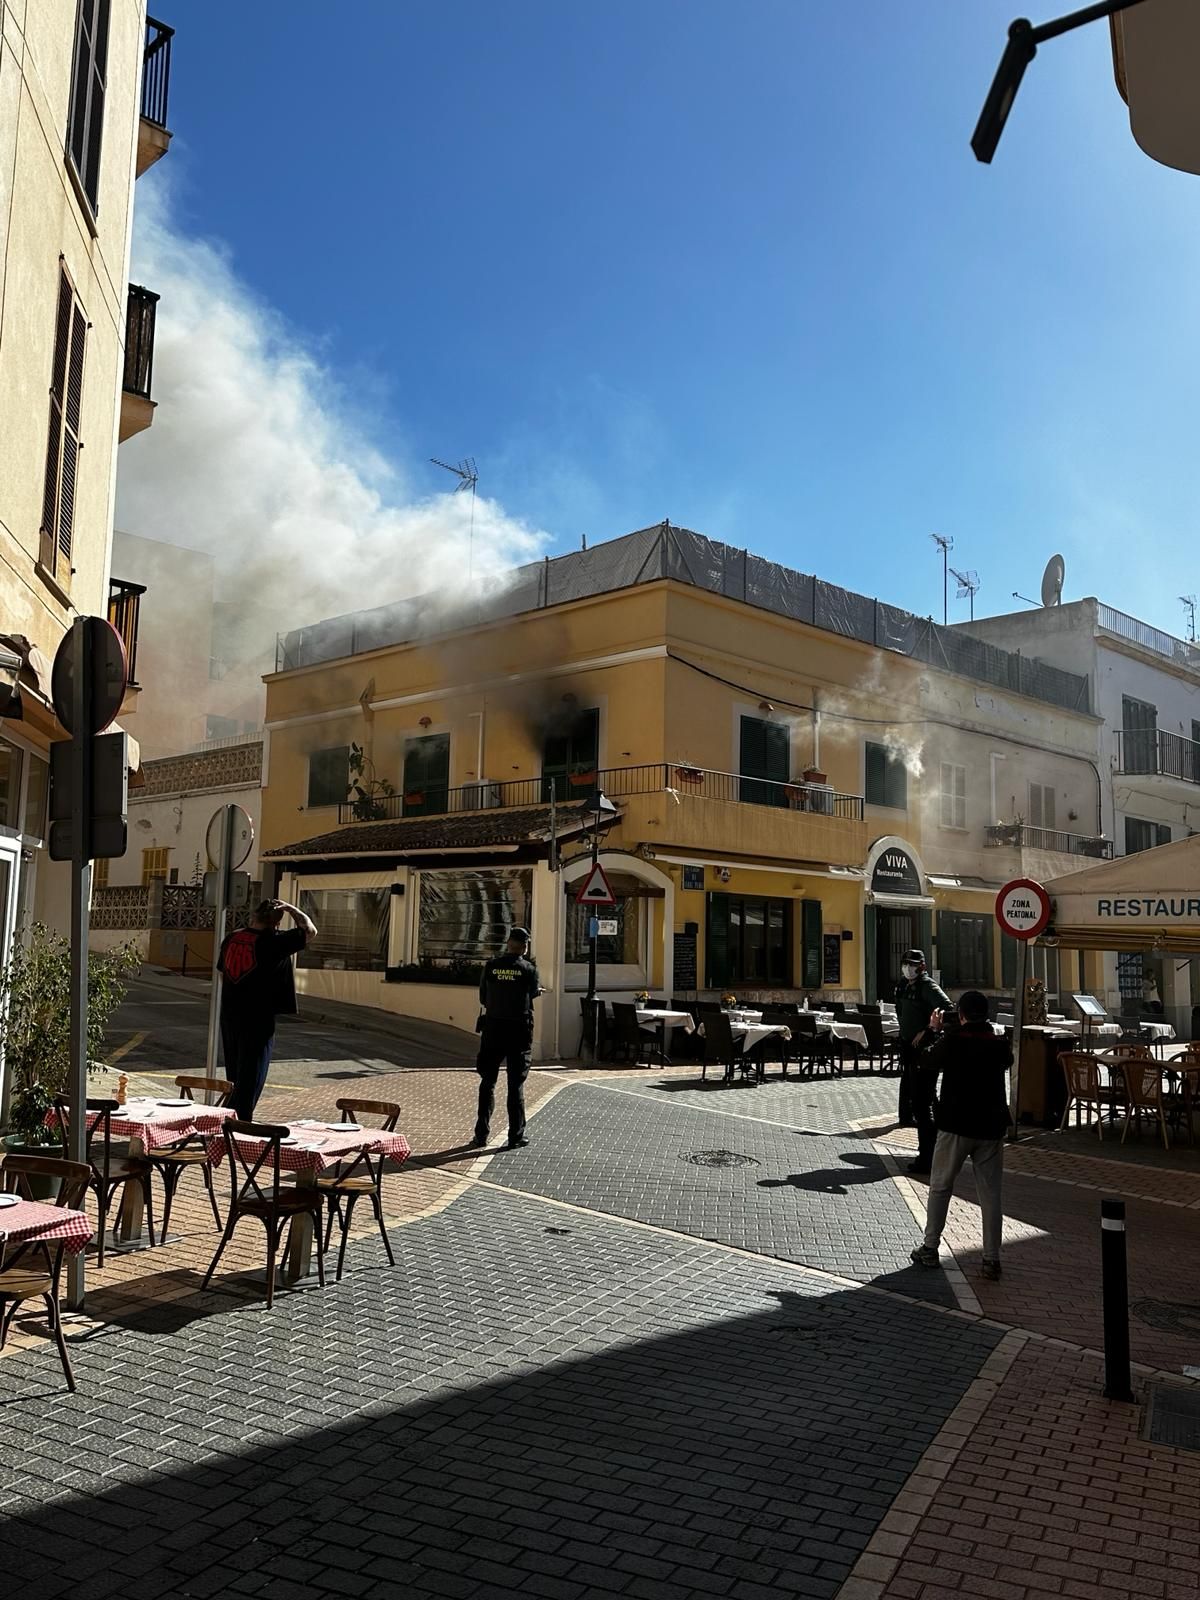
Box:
[0,1056,1200,1600]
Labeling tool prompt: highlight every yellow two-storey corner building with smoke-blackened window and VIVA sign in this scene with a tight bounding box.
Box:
[262,525,1110,1054]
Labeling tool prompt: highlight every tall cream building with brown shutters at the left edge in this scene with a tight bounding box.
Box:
[0,0,171,934]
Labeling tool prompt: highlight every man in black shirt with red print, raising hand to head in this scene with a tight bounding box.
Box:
[218,901,317,1122]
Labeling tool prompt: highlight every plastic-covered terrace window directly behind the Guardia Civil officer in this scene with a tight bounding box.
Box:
[416,867,533,968]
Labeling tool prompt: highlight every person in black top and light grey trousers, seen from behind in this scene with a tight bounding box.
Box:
[912,989,1013,1278]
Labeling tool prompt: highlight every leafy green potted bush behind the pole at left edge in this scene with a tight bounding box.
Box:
[0,923,139,1190]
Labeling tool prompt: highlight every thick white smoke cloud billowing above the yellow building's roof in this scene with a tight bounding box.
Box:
[117,179,547,643]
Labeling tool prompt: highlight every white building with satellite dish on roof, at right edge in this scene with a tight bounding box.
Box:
[968,598,1200,1038]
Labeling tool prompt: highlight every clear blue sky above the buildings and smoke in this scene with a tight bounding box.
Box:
[148,0,1200,632]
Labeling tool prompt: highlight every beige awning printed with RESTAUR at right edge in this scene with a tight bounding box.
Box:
[1043,834,1200,955]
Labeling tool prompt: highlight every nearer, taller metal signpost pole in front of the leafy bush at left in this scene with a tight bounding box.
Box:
[67,616,91,1310]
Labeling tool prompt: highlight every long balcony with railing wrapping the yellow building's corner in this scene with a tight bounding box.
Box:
[338,762,867,866]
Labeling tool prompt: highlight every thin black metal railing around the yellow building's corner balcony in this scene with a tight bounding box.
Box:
[338,762,862,822]
